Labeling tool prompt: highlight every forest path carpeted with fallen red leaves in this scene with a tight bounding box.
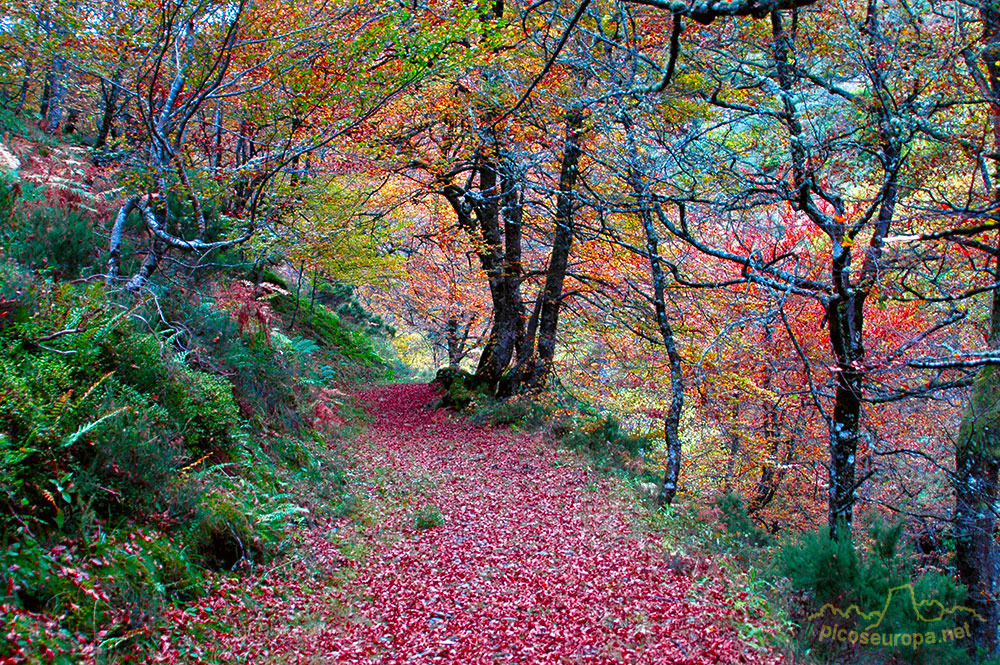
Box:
[154,384,782,665]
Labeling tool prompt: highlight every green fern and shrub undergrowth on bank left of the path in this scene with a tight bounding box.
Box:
[0,163,398,663]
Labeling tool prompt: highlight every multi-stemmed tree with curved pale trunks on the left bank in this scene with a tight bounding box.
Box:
[101,2,445,290]
